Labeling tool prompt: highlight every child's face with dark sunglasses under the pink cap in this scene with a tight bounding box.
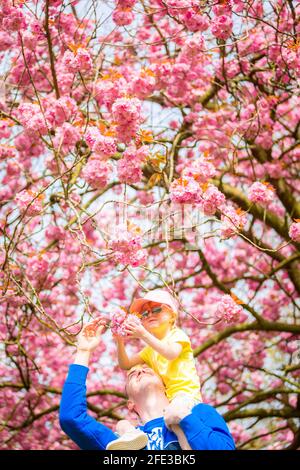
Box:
[141,302,174,333]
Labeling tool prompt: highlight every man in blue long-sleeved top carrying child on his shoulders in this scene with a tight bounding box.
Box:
[59,319,235,450]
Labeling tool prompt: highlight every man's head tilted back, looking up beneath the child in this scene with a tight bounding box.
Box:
[125,364,166,414]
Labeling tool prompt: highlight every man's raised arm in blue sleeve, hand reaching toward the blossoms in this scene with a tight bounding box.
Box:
[59,320,117,450]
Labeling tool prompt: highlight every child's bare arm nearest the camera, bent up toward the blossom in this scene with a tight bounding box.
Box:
[126,321,182,367]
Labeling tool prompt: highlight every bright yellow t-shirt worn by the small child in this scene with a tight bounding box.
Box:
[139,327,202,401]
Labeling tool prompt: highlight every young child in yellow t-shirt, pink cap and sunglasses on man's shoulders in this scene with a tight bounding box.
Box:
[107,289,202,450]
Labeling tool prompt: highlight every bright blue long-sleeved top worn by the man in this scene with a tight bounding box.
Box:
[59,364,235,450]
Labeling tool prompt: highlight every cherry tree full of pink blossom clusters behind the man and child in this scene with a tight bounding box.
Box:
[0,0,300,449]
